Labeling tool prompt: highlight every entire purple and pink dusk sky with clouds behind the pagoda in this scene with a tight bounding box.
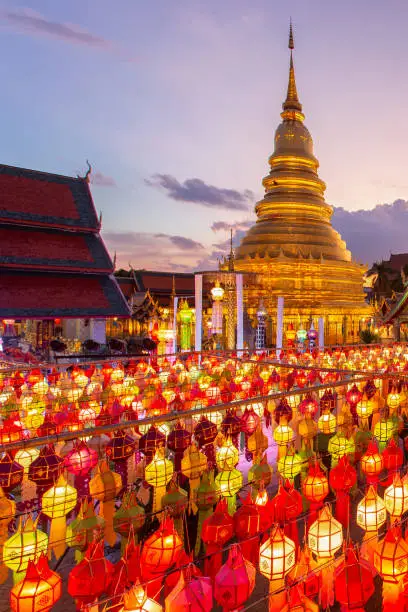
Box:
[0,0,408,270]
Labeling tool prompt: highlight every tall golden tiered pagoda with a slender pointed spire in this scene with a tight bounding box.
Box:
[235,24,370,344]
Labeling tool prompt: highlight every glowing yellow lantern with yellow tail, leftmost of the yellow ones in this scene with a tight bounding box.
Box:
[41,474,78,559]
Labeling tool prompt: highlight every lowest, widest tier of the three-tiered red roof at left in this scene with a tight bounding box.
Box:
[0,271,129,319]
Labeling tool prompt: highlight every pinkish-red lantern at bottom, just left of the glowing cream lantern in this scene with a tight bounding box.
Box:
[214,544,256,612]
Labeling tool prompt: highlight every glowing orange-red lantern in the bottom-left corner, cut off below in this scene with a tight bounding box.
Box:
[10,555,62,612]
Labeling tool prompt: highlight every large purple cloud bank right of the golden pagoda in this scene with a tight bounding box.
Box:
[332,200,408,264]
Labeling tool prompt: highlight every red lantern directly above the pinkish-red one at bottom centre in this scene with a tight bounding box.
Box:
[234,493,261,565]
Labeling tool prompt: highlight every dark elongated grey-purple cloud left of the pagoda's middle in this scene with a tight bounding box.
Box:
[145,174,254,210]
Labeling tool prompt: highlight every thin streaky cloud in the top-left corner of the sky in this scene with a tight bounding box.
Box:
[0,8,112,49]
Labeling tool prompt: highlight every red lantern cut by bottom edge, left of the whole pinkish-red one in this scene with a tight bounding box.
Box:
[165,566,213,612]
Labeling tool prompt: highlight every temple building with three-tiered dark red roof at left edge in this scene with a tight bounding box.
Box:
[0,165,129,349]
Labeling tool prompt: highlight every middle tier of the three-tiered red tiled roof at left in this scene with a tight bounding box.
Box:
[0,225,113,273]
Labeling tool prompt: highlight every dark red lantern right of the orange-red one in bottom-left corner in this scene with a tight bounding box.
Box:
[68,542,113,609]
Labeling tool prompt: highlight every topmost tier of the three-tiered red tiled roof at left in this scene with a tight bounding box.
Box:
[0,164,99,232]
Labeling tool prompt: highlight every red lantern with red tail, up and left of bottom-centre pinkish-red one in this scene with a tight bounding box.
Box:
[201,499,234,578]
